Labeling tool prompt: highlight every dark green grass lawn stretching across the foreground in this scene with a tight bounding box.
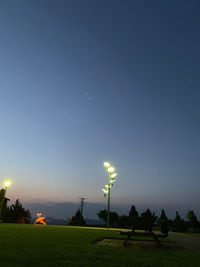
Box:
[0,224,200,267]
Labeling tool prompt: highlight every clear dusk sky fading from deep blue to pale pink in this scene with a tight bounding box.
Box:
[0,0,200,219]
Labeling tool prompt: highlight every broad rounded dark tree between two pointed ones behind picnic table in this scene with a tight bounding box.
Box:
[140,209,157,232]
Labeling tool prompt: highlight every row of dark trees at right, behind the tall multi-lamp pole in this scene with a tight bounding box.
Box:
[97,206,200,233]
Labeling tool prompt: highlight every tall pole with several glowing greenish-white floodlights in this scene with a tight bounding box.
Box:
[102,162,117,228]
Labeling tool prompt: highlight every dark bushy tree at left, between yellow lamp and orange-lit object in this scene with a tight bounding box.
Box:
[4,199,31,224]
